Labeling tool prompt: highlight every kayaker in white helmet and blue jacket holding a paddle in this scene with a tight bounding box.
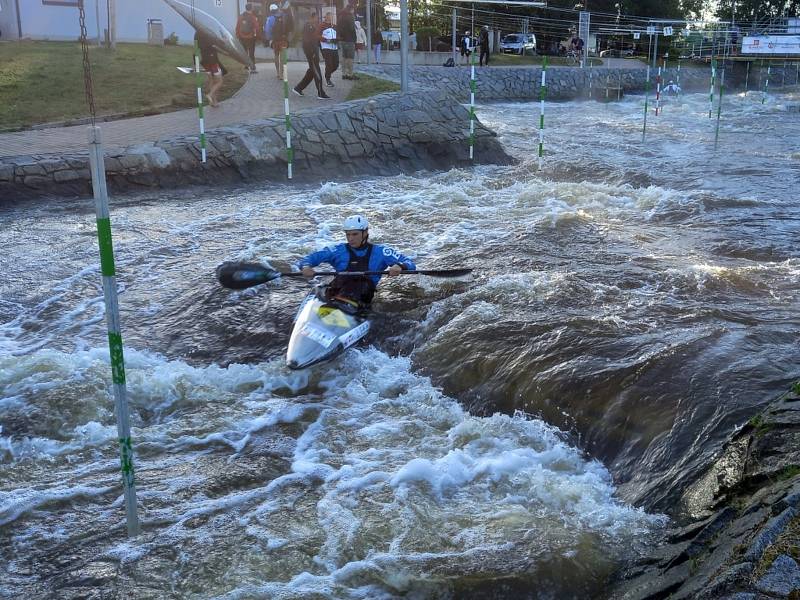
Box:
[297,215,417,309]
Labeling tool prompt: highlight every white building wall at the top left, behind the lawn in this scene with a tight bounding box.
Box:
[18,0,242,44]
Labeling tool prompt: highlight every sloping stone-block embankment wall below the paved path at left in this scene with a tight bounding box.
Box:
[0,93,512,200]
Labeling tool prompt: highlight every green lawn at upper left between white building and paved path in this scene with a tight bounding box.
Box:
[0,41,247,129]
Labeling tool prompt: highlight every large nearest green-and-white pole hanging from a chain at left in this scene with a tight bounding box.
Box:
[89,126,139,536]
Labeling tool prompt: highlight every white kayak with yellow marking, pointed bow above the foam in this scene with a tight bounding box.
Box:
[286,288,370,369]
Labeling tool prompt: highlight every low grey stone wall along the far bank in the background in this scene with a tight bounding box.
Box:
[358,65,738,102]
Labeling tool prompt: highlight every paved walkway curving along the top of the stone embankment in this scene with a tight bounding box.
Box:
[0,62,353,157]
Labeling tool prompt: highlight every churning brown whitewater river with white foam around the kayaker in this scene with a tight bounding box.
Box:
[0,92,800,599]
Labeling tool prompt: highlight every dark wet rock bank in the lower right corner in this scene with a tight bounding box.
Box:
[608,390,800,600]
